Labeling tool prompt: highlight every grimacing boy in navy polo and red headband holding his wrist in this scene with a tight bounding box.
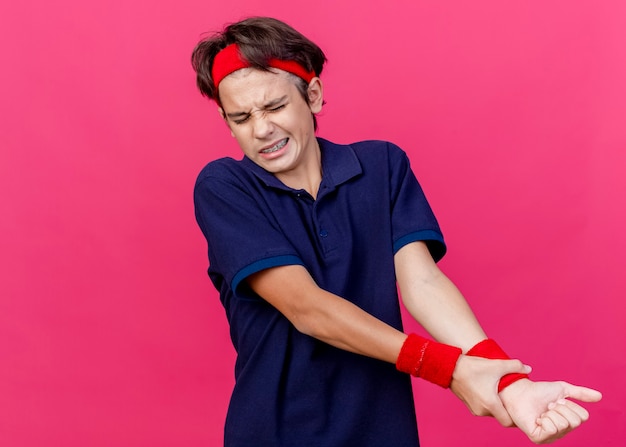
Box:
[192,18,600,447]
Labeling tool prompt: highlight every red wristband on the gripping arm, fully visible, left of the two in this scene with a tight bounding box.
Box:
[396,334,462,388]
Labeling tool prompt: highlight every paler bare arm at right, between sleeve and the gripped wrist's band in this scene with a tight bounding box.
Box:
[395,243,487,352]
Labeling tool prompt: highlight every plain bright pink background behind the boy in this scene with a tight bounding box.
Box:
[0,0,626,447]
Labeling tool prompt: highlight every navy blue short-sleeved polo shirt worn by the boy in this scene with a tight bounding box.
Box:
[194,139,445,447]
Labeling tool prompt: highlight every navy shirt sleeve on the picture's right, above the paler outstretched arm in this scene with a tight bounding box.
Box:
[389,145,446,261]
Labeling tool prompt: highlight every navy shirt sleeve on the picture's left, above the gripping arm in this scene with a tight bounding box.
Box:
[194,168,303,293]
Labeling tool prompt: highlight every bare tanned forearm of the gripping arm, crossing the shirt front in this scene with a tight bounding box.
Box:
[248,266,406,363]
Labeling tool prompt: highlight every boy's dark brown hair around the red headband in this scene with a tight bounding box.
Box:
[191,17,326,104]
